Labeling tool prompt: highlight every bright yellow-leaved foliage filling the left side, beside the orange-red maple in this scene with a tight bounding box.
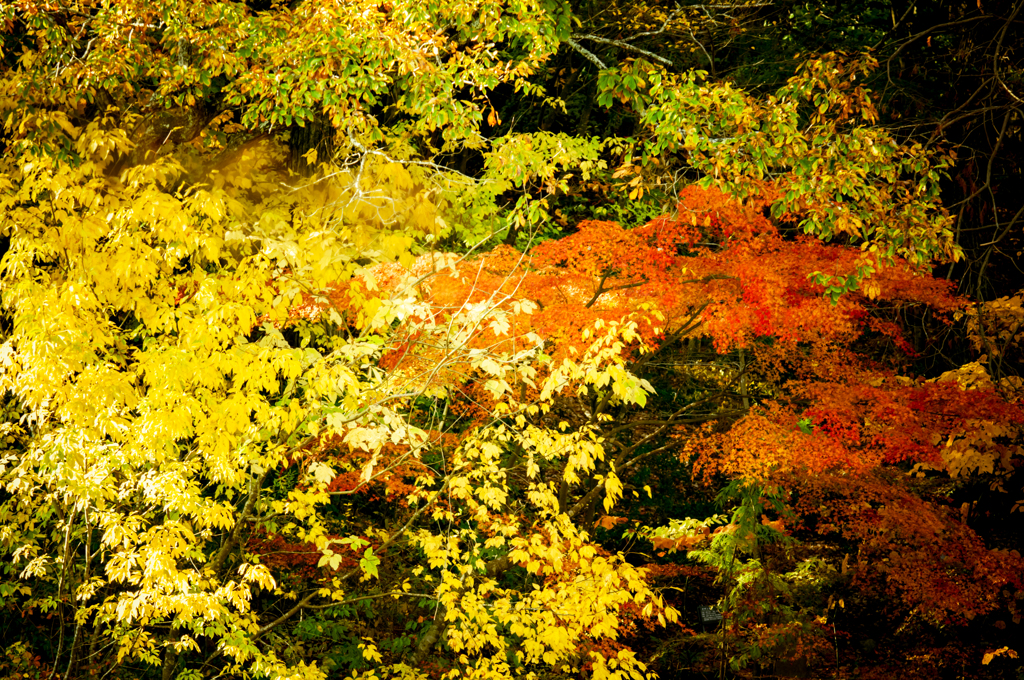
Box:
[0,0,673,680]
